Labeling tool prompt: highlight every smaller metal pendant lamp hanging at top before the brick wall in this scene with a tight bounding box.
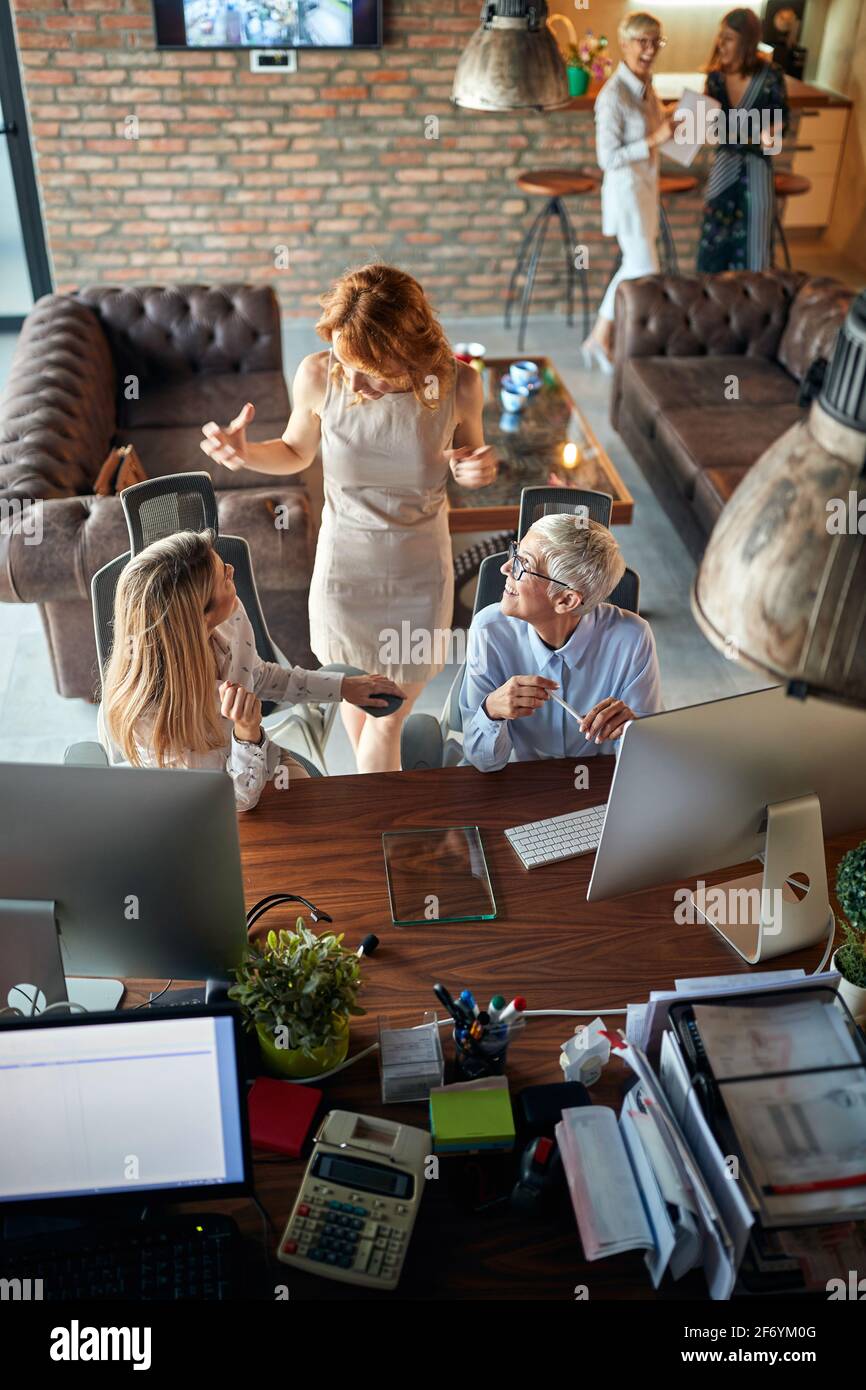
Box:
[450,0,571,111]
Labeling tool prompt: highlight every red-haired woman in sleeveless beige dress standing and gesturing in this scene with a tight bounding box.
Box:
[202,265,498,773]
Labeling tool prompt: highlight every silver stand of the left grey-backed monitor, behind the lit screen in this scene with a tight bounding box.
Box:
[0,898,124,1016]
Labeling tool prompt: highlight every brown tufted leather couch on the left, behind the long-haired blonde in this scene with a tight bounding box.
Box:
[0,284,317,699]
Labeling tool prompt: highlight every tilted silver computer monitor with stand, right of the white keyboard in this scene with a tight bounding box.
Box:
[587,687,866,965]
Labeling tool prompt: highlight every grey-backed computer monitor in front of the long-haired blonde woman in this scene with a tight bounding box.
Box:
[0,763,246,1009]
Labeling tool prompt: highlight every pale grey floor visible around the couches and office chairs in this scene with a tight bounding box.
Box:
[0,309,766,773]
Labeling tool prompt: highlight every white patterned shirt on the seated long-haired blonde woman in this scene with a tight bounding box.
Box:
[99,599,343,810]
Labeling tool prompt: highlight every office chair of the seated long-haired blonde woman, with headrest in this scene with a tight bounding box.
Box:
[90,473,336,774]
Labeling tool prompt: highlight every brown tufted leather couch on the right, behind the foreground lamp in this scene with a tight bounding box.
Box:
[610,271,853,556]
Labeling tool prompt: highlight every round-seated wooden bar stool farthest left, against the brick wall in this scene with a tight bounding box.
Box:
[505,170,601,352]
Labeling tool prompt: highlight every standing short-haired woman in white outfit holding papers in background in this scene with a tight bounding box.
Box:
[584,11,674,373]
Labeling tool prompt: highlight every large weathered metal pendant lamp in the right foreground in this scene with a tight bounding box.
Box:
[692,291,866,708]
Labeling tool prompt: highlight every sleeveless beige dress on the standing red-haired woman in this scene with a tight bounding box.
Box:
[310,357,456,681]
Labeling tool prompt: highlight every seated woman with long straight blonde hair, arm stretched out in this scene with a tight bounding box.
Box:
[100,531,402,810]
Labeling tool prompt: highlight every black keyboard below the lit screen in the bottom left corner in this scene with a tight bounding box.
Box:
[0,1213,240,1302]
